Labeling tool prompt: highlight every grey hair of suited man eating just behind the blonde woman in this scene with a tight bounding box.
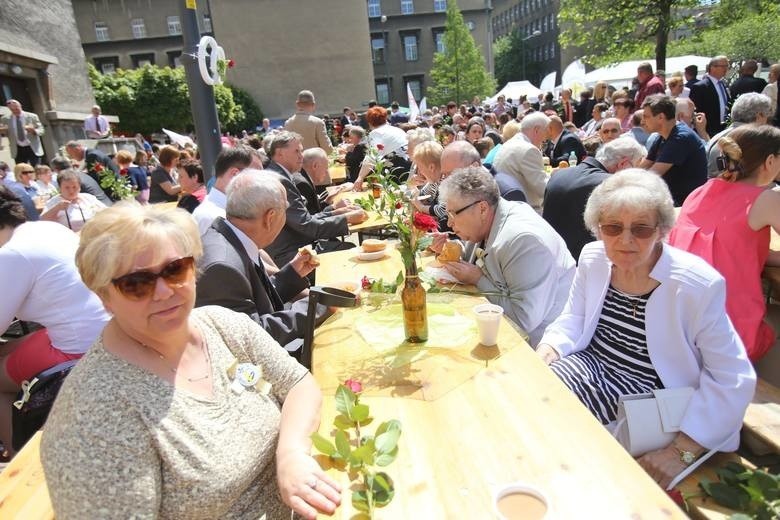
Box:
[225,168,286,219]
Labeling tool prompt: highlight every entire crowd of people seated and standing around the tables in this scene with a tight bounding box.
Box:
[0,57,780,518]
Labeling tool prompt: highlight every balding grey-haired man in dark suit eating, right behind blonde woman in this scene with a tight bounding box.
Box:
[195,170,324,345]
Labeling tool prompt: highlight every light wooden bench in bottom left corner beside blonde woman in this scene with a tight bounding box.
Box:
[0,432,54,520]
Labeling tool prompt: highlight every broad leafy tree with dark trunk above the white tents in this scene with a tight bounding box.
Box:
[558,0,698,69]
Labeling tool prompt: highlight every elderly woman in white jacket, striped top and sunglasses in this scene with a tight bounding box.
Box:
[537,169,756,487]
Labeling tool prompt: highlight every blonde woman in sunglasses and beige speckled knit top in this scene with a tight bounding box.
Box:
[41,203,340,520]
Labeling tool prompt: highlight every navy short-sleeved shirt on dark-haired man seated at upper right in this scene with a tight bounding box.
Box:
[647,122,707,206]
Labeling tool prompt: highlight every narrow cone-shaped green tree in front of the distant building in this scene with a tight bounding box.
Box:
[426,2,496,105]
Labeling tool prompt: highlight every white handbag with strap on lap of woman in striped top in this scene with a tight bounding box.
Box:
[612,386,728,489]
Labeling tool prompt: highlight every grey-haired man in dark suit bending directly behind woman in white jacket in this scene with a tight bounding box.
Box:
[542,136,645,260]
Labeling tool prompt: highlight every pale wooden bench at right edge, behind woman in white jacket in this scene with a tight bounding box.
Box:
[742,378,780,455]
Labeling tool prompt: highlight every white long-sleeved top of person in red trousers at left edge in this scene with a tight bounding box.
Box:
[0,221,110,354]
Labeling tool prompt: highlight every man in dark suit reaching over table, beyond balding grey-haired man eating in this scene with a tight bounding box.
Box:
[265,131,368,265]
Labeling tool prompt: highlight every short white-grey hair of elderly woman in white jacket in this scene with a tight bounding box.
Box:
[584,168,675,238]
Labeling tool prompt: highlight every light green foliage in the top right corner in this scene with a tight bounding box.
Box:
[669,0,780,63]
